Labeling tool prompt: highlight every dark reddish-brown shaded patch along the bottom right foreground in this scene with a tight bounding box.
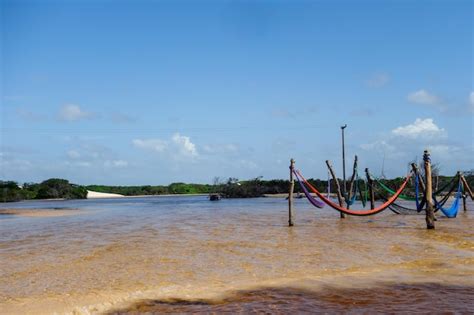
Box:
[106,284,474,315]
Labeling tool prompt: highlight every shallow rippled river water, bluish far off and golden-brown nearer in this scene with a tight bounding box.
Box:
[0,196,474,314]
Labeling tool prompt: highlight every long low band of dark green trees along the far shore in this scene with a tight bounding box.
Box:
[0,175,474,202]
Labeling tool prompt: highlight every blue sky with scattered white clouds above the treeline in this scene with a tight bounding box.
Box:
[0,0,474,185]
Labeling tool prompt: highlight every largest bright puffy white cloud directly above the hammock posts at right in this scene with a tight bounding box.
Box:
[392,118,446,139]
